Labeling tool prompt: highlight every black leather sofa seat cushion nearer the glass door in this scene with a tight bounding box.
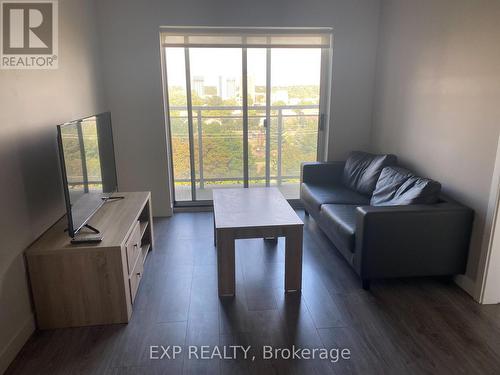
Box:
[300,182,370,211]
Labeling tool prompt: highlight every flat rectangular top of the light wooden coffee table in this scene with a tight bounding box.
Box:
[213,187,304,229]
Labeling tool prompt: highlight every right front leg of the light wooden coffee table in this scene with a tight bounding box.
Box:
[285,226,302,292]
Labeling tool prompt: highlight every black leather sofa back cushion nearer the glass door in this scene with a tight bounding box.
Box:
[342,151,397,195]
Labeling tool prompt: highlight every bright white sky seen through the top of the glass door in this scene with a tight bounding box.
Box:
[166,48,321,86]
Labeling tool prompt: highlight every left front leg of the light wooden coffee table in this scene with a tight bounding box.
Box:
[217,230,235,297]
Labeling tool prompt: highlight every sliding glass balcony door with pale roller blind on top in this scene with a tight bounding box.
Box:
[162,30,331,205]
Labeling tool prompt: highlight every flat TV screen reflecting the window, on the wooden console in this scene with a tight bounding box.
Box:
[57,112,117,237]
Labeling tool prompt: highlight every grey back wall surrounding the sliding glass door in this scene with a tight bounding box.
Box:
[94,0,379,215]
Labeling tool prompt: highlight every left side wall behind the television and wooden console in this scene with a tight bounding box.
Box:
[0,0,106,373]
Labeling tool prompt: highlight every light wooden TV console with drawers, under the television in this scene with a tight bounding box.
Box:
[26,192,153,329]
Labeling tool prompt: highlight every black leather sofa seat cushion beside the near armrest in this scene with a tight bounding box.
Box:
[320,204,357,253]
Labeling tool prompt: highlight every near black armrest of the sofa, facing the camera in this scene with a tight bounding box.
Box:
[354,203,473,280]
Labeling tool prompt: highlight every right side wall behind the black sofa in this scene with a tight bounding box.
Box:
[372,0,500,292]
